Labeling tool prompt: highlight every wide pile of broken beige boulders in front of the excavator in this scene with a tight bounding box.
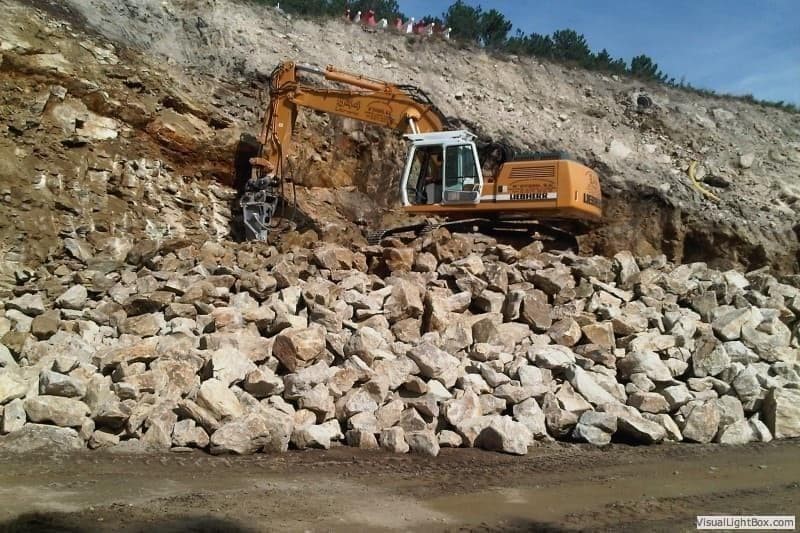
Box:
[0,230,800,455]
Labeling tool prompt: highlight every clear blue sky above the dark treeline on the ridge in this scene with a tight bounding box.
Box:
[398,0,800,104]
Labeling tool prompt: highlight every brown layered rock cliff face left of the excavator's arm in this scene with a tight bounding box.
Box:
[0,3,247,274]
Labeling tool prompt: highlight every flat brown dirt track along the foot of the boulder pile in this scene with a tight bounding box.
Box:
[0,440,800,532]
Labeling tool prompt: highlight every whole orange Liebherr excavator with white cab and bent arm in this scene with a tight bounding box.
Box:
[240,62,602,240]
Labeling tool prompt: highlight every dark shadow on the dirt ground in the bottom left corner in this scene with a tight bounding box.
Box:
[0,513,255,533]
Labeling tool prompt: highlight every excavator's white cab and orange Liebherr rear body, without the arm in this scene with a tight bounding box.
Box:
[400,127,602,221]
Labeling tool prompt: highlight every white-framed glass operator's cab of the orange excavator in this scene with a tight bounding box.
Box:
[400,130,483,207]
